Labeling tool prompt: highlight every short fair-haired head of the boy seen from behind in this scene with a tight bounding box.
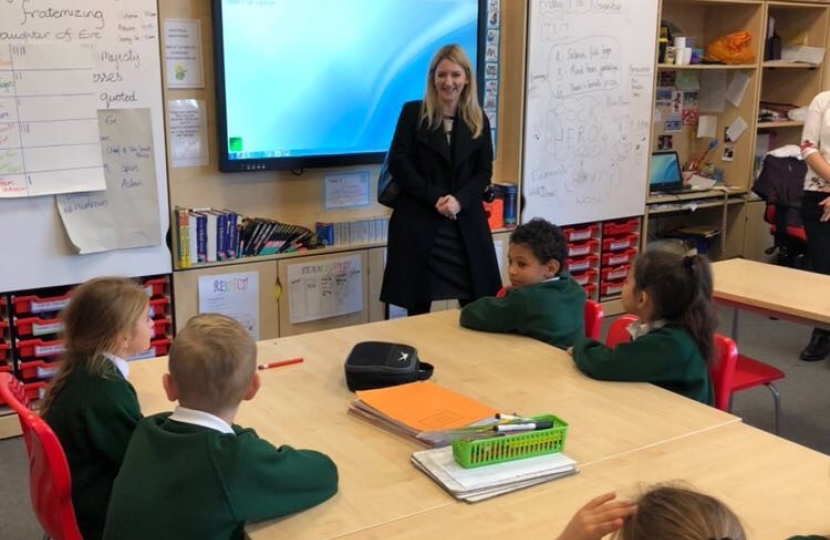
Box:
[167,313,256,414]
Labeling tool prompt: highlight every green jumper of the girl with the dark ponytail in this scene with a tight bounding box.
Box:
[573,326,715,405]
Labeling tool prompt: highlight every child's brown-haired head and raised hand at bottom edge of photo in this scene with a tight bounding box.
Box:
[556,485,827,540]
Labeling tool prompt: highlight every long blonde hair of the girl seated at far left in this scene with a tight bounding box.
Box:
[41,277,149,414]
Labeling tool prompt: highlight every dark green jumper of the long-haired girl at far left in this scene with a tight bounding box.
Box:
[44,358,141,540]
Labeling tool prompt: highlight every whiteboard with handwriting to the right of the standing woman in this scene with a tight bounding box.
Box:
[522,0,658,225]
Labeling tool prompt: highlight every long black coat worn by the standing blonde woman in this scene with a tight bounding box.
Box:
[380,101,501,307]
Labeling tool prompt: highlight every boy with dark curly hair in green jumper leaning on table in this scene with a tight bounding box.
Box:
[459,218,585,349]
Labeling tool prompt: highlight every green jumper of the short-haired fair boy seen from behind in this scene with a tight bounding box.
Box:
[104,413,337,540]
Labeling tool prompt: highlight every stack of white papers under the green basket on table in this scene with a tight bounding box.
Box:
[412,446,577,502]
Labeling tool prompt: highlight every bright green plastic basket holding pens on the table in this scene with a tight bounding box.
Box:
[452,414,568,469]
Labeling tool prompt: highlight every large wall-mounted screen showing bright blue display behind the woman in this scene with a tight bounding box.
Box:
[214,0,480,170]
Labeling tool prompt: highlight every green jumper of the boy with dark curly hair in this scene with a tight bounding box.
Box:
[459,272,585,349]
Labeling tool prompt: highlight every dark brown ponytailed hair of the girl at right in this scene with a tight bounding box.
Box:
[633,249,718,362]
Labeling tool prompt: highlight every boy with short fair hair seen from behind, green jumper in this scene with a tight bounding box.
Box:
[104,314,338,540]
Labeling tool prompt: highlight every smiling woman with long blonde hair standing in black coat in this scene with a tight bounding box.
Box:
[380,45,501,315]
